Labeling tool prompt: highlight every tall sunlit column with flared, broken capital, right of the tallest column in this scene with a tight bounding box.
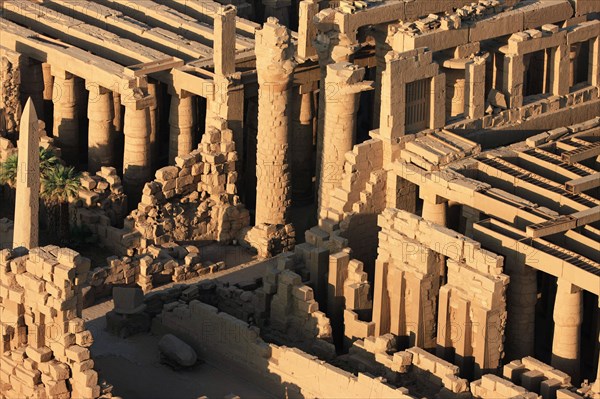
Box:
[317,62,372,219]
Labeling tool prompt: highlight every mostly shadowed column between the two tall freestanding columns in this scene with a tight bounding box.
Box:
[291,87,314,200]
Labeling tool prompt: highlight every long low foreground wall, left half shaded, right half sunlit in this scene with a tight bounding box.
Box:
[153,301,418,399]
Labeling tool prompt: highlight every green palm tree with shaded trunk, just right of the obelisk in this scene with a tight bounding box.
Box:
[40,164,81,241]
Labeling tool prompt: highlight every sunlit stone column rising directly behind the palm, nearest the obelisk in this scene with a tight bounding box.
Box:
[52,68,79,165]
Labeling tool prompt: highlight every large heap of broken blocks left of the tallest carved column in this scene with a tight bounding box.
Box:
[130,129,250,247]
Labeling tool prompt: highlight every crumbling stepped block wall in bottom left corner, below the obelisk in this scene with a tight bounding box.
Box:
[0,246,100,399]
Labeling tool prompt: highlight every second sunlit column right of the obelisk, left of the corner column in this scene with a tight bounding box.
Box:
[86,83,115,174]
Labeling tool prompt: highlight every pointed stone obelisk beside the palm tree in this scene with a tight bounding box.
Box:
[13,98,40,249]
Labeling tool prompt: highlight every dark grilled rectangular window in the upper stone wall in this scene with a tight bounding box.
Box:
[405,78,431,133]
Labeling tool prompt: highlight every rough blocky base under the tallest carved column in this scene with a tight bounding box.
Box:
[239,223,296,258]
